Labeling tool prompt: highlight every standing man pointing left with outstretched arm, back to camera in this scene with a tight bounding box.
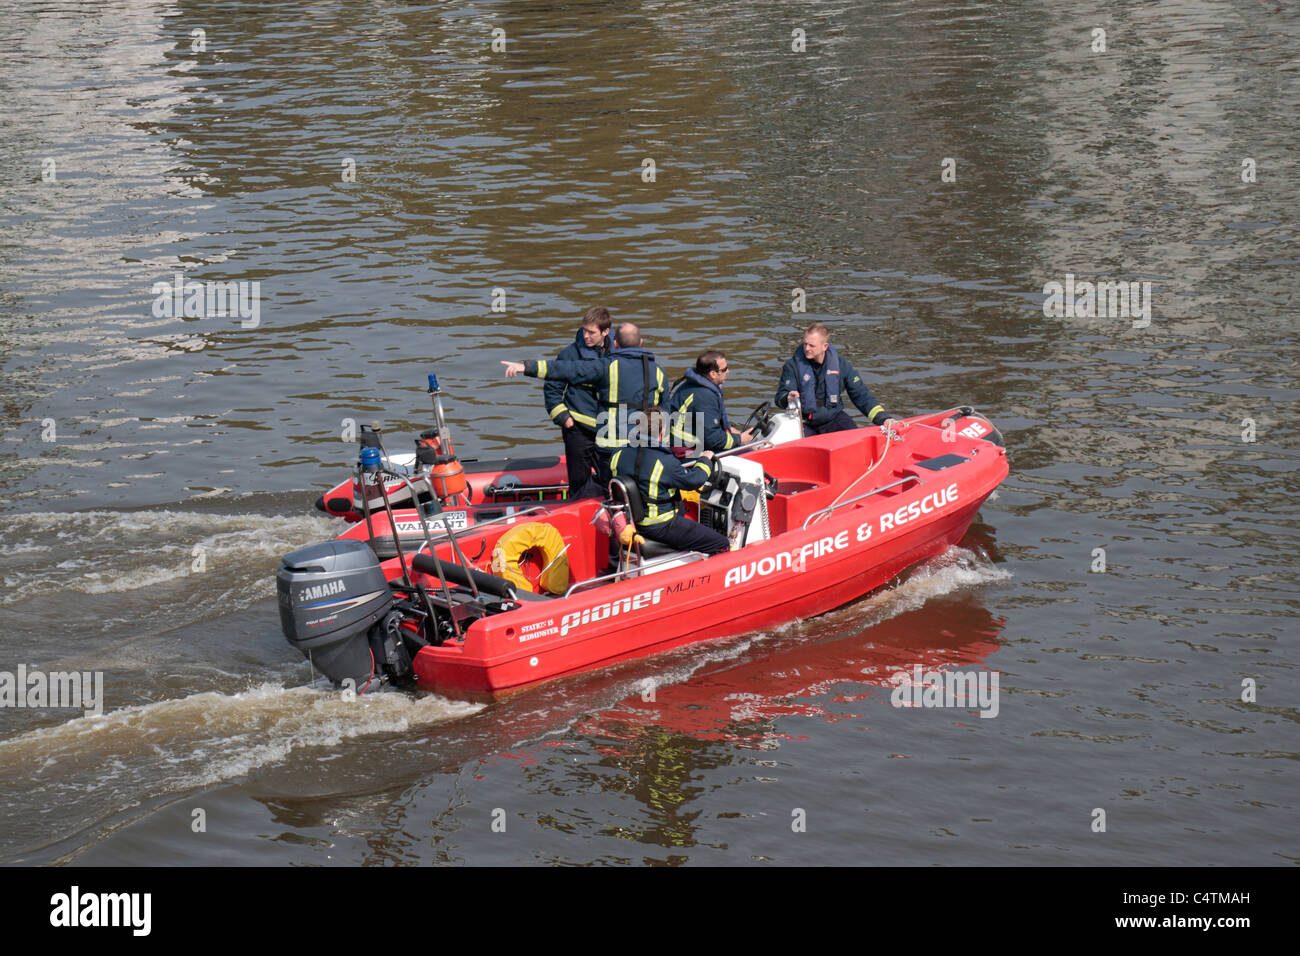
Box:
[501,323,663,488]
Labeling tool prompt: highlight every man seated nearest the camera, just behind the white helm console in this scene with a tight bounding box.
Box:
[610,405,731,554]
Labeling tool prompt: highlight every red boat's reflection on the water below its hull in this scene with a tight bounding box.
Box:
[502,546,1006,865]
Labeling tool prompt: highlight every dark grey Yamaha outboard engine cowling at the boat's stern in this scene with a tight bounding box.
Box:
[276,541,397,685]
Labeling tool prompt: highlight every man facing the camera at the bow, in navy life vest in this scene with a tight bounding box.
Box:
[776,324,893,434]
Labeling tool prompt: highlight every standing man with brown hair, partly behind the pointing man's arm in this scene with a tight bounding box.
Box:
[542,306,614,498]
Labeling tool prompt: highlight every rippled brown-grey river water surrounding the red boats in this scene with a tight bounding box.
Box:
[0,0,1300,865]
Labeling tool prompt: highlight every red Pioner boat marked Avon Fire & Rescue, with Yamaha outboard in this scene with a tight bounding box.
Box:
[271,407,1008,697]
